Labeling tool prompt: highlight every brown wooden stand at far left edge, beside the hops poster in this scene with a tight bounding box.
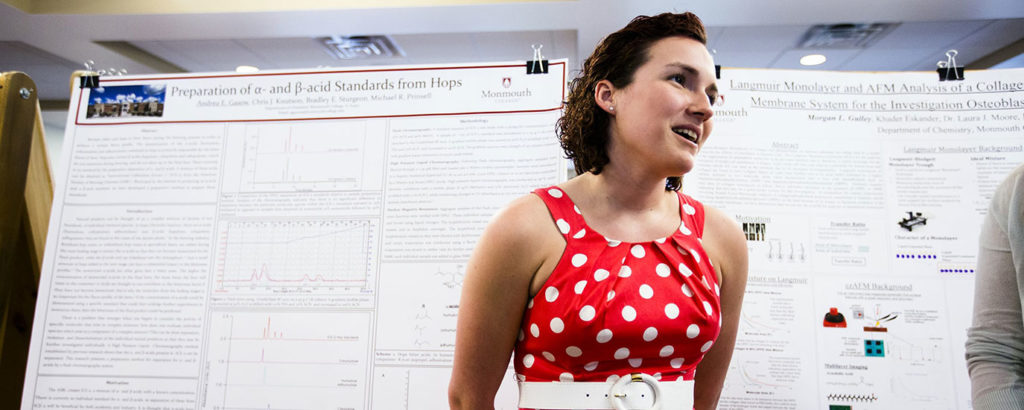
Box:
[0,72,53,409]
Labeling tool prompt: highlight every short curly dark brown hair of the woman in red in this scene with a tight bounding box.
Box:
[557,12,708,191]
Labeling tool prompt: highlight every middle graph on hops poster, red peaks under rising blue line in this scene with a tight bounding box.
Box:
[215,219,379,292]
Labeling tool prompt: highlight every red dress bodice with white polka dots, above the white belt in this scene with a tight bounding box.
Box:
[514,187,722,397]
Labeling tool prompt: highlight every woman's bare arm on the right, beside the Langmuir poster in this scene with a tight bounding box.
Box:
[693,206,748,410]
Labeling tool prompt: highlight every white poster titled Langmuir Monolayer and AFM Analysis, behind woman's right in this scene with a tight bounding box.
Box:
[684,65,1024,410]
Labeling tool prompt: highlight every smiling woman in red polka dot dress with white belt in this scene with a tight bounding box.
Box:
[449,13,746,409]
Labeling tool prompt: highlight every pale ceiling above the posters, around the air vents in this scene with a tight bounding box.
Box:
[0,0,1024,108]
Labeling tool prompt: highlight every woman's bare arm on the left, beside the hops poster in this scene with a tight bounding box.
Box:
[449,195,564,410]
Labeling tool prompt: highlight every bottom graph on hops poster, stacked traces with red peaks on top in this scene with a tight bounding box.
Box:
[203,312,370,410]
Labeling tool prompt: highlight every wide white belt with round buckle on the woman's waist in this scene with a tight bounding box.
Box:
[519,373,693,410]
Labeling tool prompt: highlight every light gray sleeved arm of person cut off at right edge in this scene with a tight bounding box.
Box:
[966,166,1024,410]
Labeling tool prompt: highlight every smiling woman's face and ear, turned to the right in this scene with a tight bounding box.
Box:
[597,37,718,176]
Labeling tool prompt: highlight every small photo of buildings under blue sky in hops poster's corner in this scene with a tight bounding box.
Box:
[85,84,167,118]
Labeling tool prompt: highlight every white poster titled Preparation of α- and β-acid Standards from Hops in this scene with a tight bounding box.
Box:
[22,60,567,410]
